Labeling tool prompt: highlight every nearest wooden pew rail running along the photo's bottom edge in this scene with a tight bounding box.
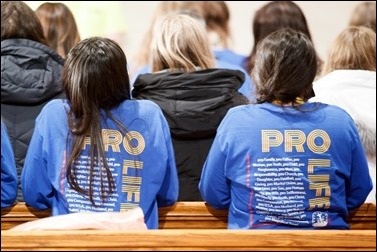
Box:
[1,229,376,251]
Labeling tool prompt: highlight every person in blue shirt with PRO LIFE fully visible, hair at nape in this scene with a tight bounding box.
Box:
[199,29,372,229]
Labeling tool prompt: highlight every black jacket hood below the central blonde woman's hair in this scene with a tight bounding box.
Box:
[132,69,248,139]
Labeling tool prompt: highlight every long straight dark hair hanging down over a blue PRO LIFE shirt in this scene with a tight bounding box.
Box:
[63,37,130,204]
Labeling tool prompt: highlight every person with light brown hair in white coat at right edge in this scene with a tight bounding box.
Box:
[311,26,376,202]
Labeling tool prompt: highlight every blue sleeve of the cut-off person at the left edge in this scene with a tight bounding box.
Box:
[1,121,18,208]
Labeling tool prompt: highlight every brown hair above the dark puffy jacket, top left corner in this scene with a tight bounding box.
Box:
[1,1,48,46]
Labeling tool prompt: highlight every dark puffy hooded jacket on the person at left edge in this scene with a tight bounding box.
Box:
[1,39,64,201]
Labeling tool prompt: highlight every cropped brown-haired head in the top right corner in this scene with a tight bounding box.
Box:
[349,2,376,32]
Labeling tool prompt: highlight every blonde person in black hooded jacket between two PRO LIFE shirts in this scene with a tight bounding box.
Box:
[132,15,247,201]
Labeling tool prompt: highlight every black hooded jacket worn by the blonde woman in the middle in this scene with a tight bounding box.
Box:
[132,69,248,201]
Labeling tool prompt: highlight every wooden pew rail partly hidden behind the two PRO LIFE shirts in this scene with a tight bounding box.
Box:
[1,202,376,230]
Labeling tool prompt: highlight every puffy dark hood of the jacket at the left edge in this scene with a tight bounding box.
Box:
[1,39,64,105]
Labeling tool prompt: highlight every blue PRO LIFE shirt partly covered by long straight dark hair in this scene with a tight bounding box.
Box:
[21,100,178,229]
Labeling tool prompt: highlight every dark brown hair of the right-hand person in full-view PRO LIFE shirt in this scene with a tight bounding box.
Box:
[252,28,317,105]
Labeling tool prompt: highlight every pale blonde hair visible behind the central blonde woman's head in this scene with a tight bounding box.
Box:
[131,1,203,75]
